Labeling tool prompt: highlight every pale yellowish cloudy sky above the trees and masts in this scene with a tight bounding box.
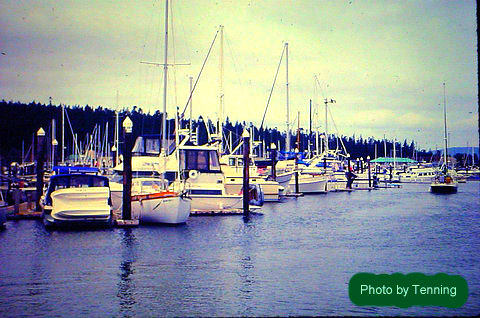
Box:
[0,0,478,149]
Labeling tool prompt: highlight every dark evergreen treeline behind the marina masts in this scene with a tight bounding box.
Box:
[0,100,433,165]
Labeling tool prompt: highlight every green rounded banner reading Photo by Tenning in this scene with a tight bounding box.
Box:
[348,273,468,308]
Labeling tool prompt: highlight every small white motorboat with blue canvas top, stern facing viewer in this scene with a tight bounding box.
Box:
[41,173,112,226]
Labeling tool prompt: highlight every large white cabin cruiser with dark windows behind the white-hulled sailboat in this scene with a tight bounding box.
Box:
[113,132,263,212]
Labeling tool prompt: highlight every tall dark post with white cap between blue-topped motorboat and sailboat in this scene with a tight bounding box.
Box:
[122,116,133,221]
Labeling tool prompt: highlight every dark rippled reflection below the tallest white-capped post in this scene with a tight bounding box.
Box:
[117,228,137,317]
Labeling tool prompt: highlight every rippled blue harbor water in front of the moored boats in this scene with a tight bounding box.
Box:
[0,182,480,317]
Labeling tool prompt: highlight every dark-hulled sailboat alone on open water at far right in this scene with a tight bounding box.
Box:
[430,83,458,194]
